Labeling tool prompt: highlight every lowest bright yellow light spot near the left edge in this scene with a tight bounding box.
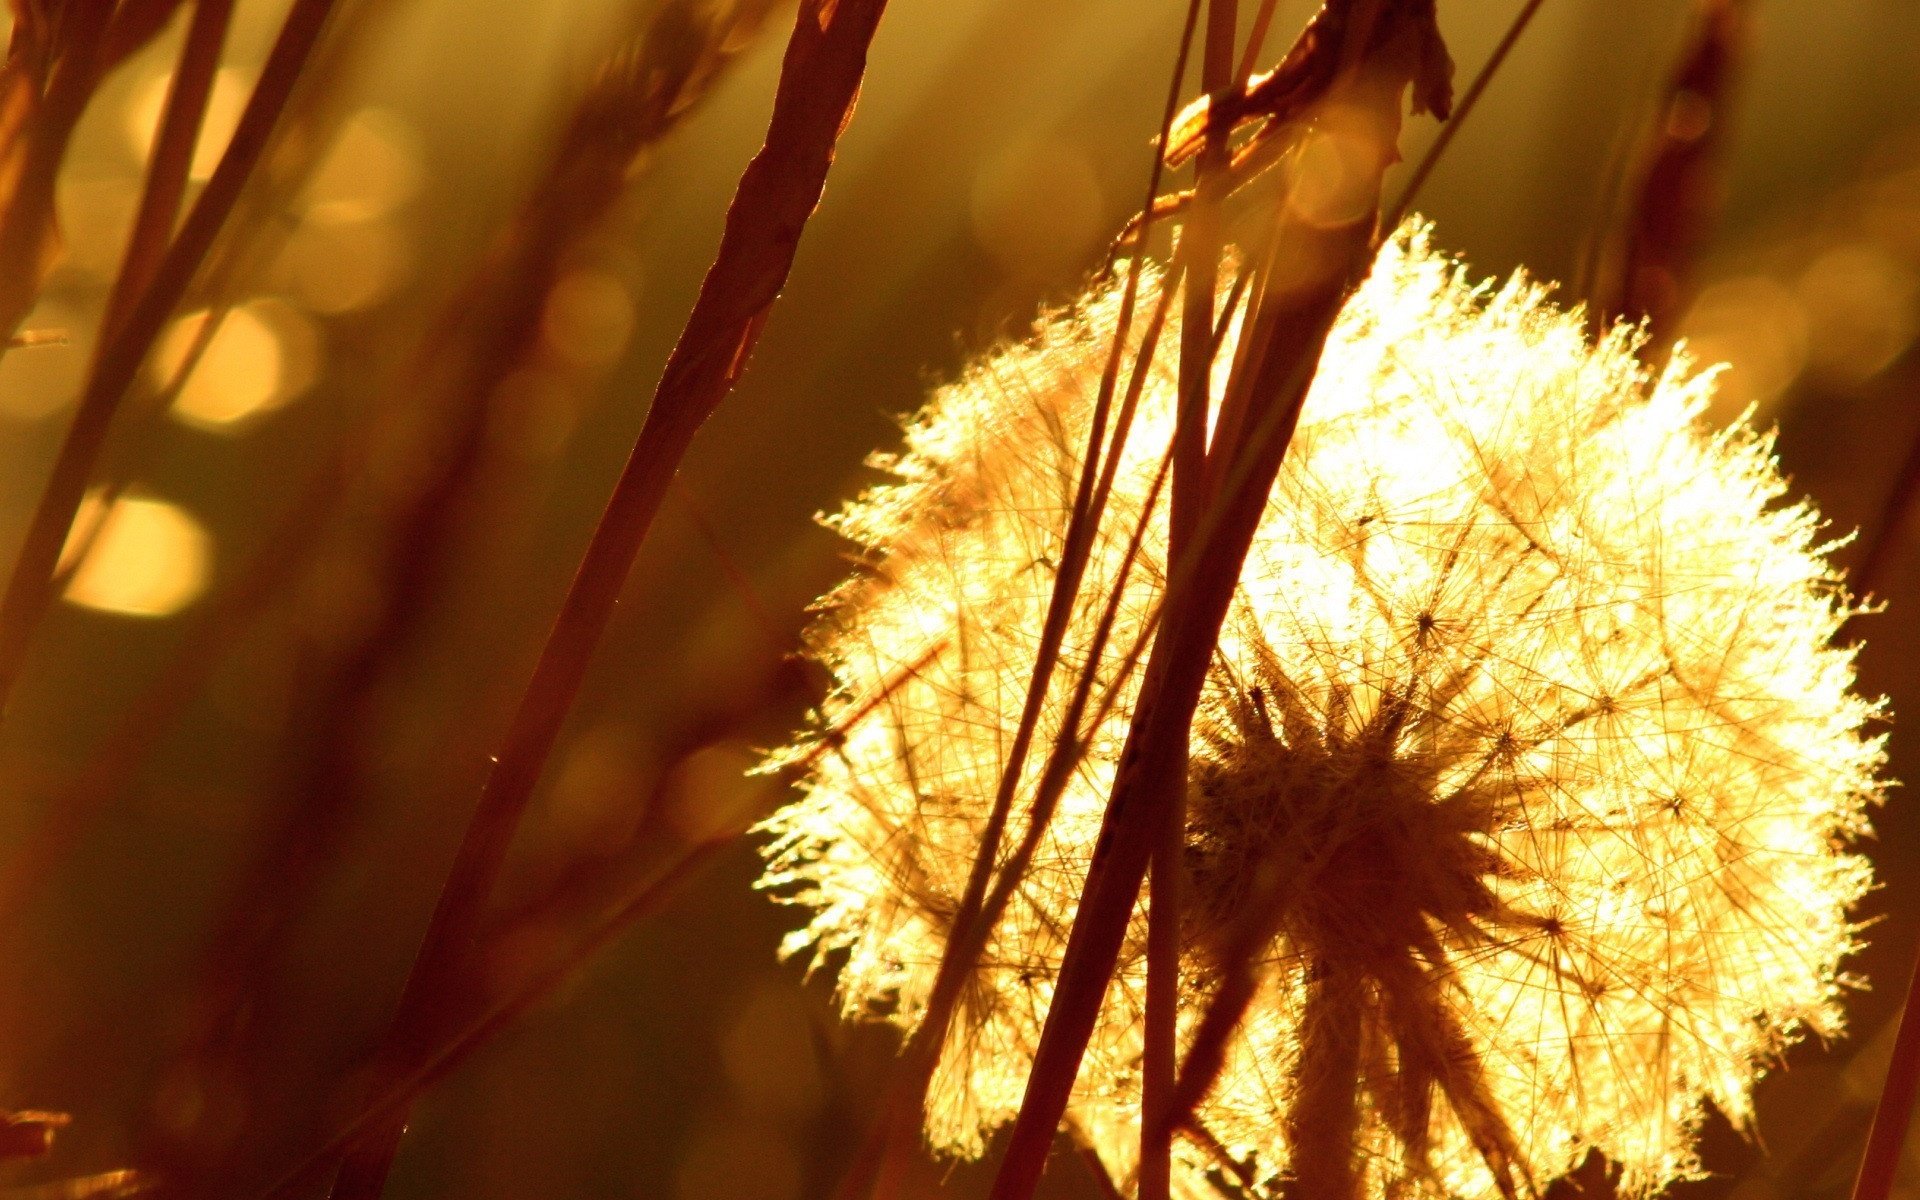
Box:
[65,495,213,616]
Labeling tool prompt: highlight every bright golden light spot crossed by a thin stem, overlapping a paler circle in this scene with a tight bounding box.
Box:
[148,300,321,432]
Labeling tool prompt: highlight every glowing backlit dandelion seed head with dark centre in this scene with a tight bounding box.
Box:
[764,227,1882,1200]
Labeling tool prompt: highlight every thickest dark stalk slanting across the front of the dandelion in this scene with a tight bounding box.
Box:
[993,2,1446,1200]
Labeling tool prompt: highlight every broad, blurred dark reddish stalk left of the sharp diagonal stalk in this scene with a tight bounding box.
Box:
[137,0,774,1192]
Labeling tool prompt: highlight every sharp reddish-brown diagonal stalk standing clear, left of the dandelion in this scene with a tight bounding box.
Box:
[332,0,885,1200]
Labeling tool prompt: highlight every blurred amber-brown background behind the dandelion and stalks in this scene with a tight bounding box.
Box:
[0,0,1920,1200]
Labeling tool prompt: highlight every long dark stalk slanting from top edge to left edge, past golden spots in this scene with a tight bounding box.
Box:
[0,0,336,714]
